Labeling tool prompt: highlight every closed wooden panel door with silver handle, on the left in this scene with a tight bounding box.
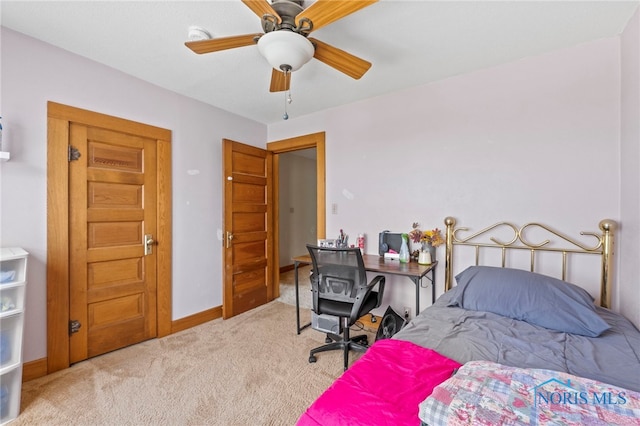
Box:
[69,123,157,363]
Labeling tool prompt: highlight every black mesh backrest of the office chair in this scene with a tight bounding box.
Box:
[307,244,367,311]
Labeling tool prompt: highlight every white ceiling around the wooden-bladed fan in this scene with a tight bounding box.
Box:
[0,0,640,124]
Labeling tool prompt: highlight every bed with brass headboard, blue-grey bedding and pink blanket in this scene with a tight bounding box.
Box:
[298,217,640,426]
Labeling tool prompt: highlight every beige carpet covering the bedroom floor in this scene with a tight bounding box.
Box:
[16,301,373,426]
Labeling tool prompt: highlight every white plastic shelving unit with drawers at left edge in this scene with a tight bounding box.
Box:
[0,247,29,425]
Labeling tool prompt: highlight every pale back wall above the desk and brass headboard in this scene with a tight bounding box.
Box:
[269,37,639,322]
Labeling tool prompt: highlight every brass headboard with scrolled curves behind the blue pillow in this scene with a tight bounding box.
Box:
[444,216,616,308]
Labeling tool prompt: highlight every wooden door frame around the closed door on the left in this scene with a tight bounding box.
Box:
[47,101,172,374]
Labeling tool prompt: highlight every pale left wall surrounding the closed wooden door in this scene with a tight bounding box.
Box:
[0,28,267,361]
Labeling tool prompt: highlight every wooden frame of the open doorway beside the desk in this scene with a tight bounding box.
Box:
[267,132,327,299]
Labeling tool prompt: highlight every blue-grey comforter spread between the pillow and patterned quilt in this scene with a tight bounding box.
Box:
[394,287,640,392]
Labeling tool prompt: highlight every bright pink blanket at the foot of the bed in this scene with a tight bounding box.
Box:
[297,339,461,426]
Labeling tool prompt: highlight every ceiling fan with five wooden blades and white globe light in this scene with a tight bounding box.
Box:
[185,0,378,92]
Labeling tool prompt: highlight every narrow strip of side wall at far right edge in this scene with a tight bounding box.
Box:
[614,5,640,327]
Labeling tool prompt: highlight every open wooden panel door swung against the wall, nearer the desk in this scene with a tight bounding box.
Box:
[222,139,274,318]
